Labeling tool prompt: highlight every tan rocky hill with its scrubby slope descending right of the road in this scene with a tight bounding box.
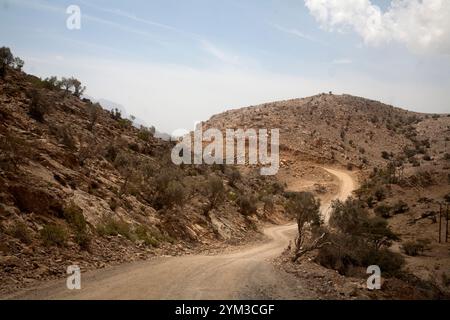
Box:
[206,94,450,298]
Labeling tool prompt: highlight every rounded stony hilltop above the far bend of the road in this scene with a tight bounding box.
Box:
[207,94,446,168]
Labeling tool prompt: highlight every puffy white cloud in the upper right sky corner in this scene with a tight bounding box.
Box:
[305,0,450,54]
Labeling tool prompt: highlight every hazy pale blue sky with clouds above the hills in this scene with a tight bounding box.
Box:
[0,0,450,132]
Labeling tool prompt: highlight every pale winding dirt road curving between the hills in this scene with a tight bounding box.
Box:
[3,168,355,299]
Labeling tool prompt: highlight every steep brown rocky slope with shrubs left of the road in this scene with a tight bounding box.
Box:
[0,62,283,291]
